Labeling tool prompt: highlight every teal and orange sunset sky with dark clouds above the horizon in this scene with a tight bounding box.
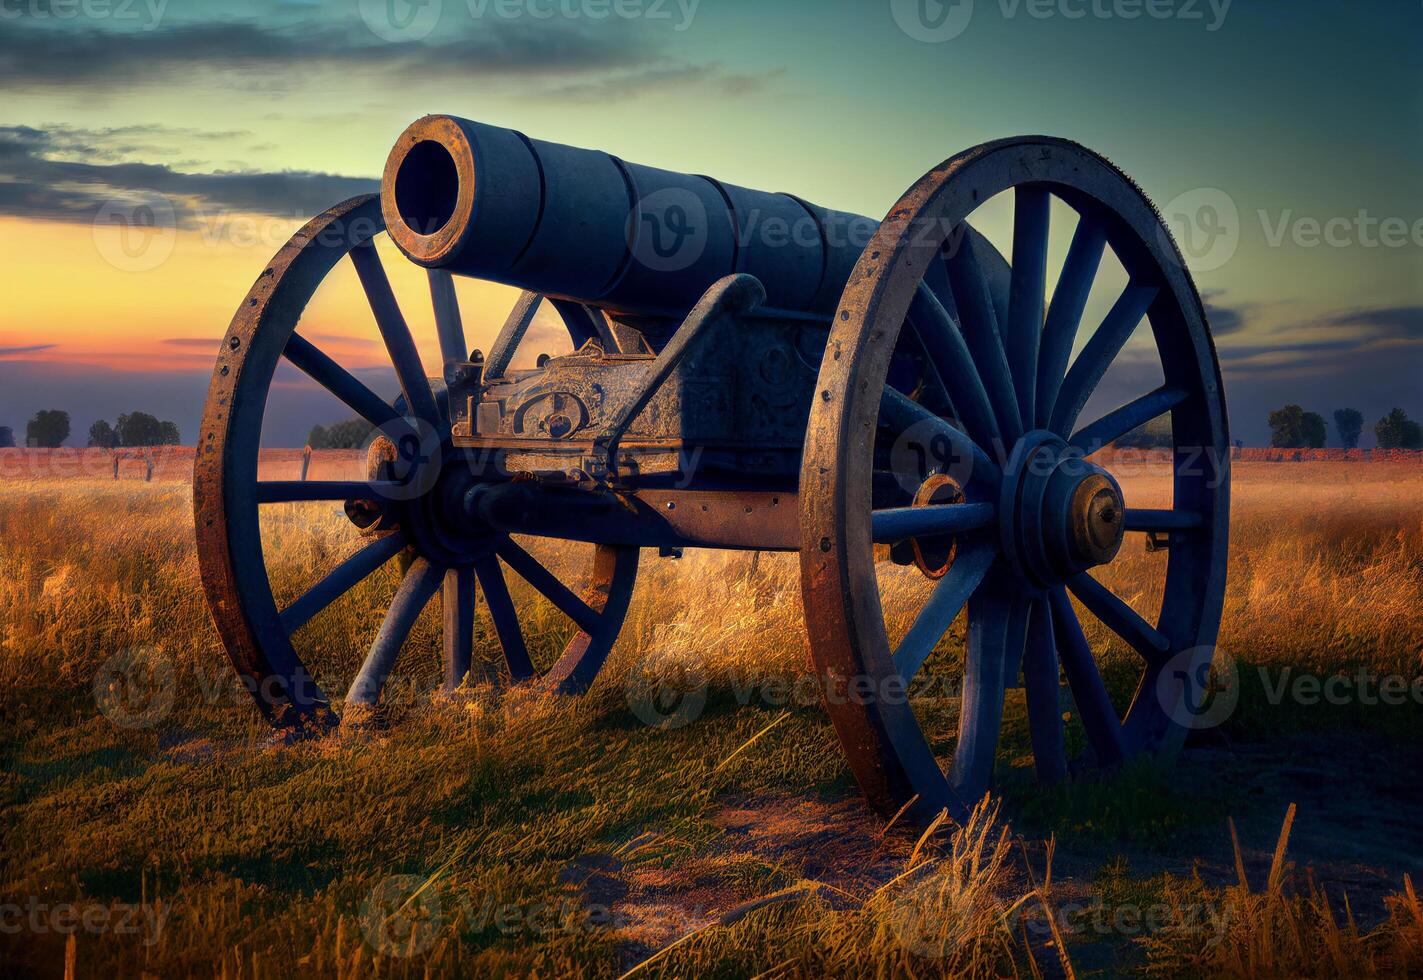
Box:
[0,0,1423,445]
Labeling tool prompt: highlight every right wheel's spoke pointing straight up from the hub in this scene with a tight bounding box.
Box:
[1003,183,1050,425]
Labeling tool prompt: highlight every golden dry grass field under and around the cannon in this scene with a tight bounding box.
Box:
[0,457,1423,977]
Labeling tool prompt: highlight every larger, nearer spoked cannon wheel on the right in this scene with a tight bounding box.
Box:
[800,137,1229,812]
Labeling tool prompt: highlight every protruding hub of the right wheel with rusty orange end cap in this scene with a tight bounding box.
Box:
[999,430,1126,590]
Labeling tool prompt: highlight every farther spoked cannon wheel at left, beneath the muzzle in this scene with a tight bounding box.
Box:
[194,195,638,730]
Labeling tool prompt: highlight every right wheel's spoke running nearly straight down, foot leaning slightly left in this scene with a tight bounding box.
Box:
[949,579,1029,806]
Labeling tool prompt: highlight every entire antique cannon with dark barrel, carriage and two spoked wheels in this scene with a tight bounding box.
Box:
[194,117,1229,814]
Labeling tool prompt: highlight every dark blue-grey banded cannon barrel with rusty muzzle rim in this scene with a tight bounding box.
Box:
[381,115,878,317]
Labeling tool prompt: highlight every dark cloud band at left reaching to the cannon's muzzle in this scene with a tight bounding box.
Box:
[0,127,379,226]
